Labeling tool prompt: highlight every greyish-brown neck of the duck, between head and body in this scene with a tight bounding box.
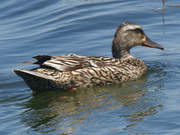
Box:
[112,40,132,59]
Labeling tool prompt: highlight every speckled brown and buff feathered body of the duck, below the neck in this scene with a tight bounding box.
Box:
[13,54,147,91]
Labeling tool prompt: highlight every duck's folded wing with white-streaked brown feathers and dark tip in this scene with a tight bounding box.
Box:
[21,54,115,72]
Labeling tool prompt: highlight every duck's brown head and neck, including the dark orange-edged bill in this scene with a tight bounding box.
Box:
[112,22,164,59]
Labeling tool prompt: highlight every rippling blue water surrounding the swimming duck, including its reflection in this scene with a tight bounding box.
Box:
[0,0,180,135]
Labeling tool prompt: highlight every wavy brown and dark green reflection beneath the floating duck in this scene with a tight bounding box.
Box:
[21,64,163,133]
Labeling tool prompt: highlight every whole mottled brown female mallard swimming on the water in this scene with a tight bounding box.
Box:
[13,22,164,91]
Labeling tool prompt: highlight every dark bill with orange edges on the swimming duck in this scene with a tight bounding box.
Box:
[142,37,164,50]
